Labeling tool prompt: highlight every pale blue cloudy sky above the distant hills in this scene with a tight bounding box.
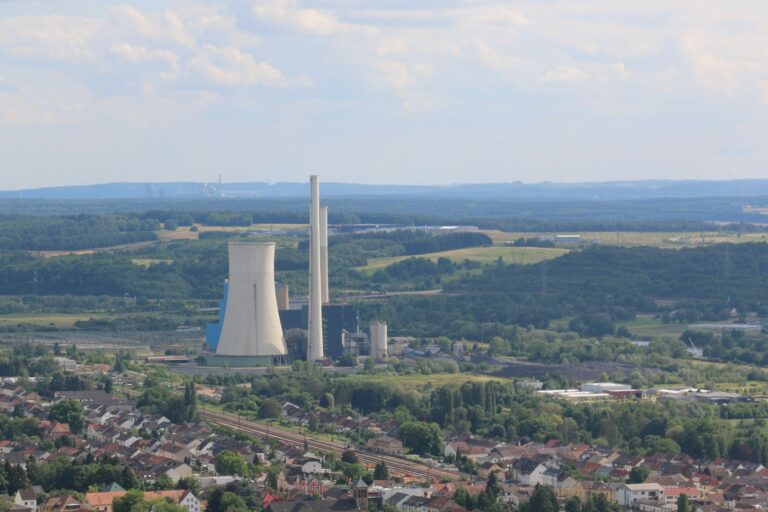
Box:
[0,0,768,189]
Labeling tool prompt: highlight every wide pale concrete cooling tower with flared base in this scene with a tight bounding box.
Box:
[216,242,287,356]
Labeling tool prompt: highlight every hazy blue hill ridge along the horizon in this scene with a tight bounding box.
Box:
[7,180,768,201]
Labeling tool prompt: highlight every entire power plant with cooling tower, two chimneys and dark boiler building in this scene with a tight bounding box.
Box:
[206,176,388,367]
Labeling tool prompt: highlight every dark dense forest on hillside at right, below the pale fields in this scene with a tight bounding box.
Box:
[446,243,768,320]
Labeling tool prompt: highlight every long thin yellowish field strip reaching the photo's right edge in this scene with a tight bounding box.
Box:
[483,230,768,249]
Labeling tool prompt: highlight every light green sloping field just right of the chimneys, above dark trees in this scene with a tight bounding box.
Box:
[358,245,569,272]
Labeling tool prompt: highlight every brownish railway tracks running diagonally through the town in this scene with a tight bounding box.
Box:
[200,411,462,480]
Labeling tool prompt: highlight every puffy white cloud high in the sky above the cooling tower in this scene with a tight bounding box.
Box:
[188,45,286,86]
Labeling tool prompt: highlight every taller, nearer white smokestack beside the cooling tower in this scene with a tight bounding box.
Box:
[307,176,323,361]
